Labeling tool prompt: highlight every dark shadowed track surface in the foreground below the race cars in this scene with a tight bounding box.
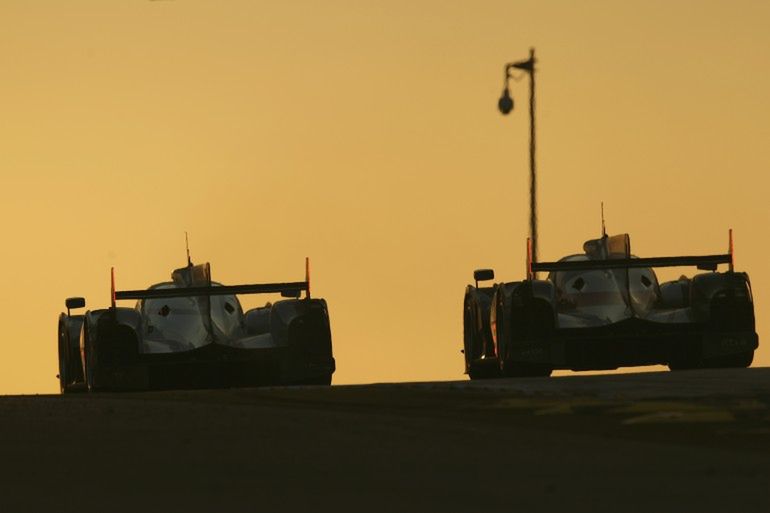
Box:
[0,369,770,513]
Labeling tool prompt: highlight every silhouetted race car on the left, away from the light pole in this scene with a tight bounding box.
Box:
[58,263,335,392]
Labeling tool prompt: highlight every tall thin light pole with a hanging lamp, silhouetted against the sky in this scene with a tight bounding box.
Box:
[497,48,537,278]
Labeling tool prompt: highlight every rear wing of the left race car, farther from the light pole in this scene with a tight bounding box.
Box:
[111,258,310,308]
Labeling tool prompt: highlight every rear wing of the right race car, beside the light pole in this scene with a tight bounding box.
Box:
[527,230,735,279]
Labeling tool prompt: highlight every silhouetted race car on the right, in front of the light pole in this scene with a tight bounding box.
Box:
[463,232,759,379]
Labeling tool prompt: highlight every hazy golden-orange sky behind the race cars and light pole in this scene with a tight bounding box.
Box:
[0,0,770,393]
